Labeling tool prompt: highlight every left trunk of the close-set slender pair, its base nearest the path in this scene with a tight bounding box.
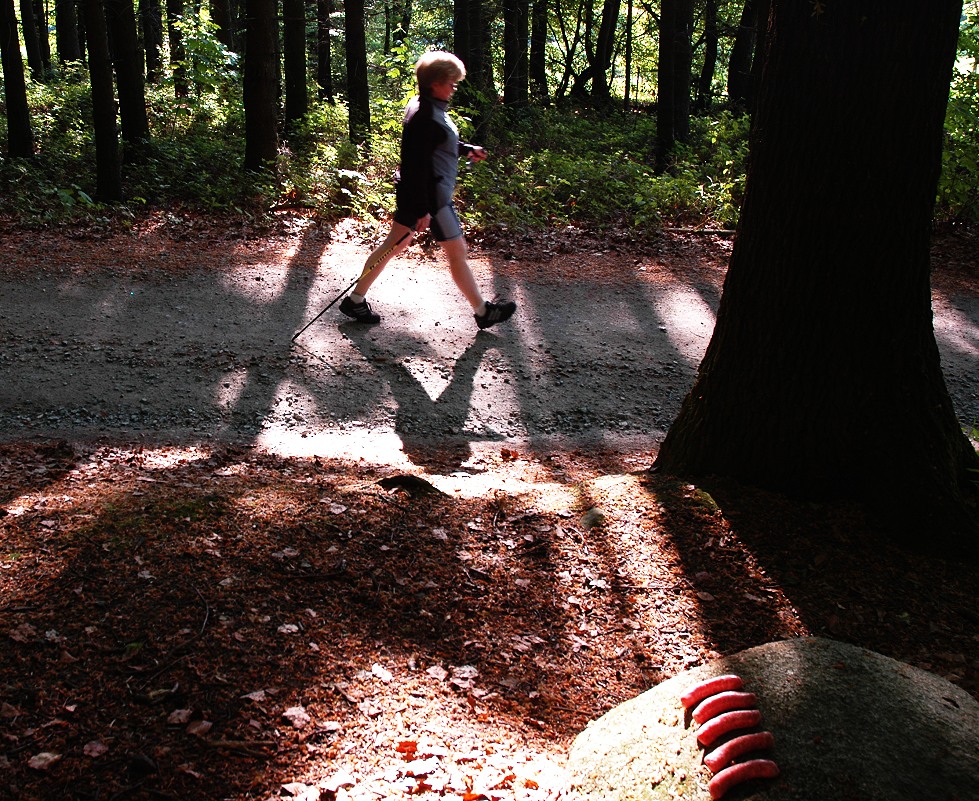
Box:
[82,0,122,203]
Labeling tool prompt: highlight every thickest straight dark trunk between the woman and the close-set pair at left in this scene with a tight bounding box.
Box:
[242,0,279,172]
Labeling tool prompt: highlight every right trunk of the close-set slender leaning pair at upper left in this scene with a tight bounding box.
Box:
[104,0,150,161]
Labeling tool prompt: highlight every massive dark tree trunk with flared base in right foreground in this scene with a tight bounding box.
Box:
[657,0,979,554]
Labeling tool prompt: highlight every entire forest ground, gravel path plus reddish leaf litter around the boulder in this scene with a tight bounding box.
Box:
[0,218,979,801]
